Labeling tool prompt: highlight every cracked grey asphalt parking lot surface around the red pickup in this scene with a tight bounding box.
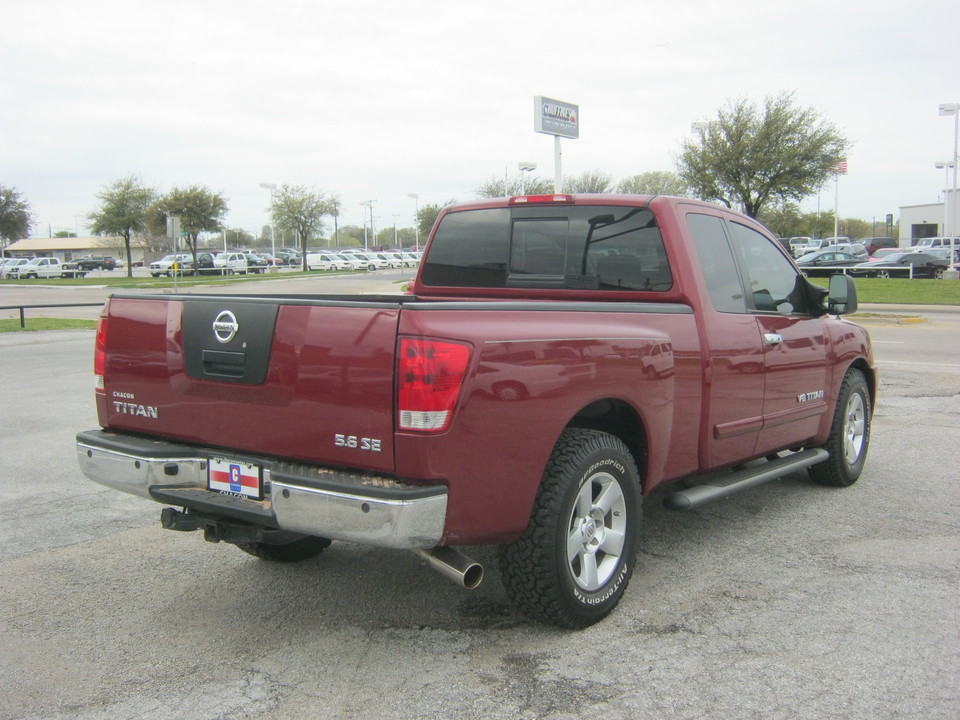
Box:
[0,282,960,720]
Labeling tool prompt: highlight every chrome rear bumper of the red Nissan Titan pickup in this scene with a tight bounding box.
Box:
[77,430,447,549]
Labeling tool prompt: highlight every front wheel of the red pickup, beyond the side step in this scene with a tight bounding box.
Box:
[810,369,871,487]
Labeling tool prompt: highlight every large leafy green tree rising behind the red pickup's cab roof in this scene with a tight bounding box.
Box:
[677,94,849,217]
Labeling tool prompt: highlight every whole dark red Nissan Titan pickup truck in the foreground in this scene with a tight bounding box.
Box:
[77,195,877,627]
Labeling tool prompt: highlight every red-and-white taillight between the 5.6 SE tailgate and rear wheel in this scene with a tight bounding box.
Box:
[397,338,470,432]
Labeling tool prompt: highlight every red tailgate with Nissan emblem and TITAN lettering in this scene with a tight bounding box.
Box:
[98,295,400,472]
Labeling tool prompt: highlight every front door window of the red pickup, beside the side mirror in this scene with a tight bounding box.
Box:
[729,222,809,315]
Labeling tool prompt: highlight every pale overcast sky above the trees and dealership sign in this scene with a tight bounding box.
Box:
[0,0,960,242]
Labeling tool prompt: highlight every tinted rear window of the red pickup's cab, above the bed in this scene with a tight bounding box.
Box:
[421,205,673,292]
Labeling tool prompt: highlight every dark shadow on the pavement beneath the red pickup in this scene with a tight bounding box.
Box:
[158,472,835,630]
